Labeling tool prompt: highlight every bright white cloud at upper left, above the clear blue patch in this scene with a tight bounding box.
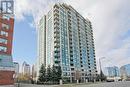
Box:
[14,0,63,22]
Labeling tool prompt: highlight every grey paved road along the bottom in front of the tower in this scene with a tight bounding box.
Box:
[0,82,130,87]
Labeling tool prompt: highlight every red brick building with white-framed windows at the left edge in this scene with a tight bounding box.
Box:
[0,14,14,85]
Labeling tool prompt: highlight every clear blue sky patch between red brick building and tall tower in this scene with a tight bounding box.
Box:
[13,16,37,65]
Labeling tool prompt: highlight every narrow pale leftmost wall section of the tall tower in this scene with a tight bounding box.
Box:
[36,16,46,78]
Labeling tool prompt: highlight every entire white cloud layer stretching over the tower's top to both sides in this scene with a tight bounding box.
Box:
[15,0,130,71]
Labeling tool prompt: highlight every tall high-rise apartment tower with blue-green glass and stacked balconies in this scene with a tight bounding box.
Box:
[37,4,97,81]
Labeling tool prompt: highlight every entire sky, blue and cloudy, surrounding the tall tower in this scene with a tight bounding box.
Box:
[13,0,130,72]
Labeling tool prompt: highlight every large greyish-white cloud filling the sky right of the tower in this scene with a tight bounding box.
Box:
[86,0,130,66]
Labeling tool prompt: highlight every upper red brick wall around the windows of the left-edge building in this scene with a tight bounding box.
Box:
[0,15,14,55]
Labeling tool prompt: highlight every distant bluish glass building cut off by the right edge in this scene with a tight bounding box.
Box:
[120,64,130,80]
